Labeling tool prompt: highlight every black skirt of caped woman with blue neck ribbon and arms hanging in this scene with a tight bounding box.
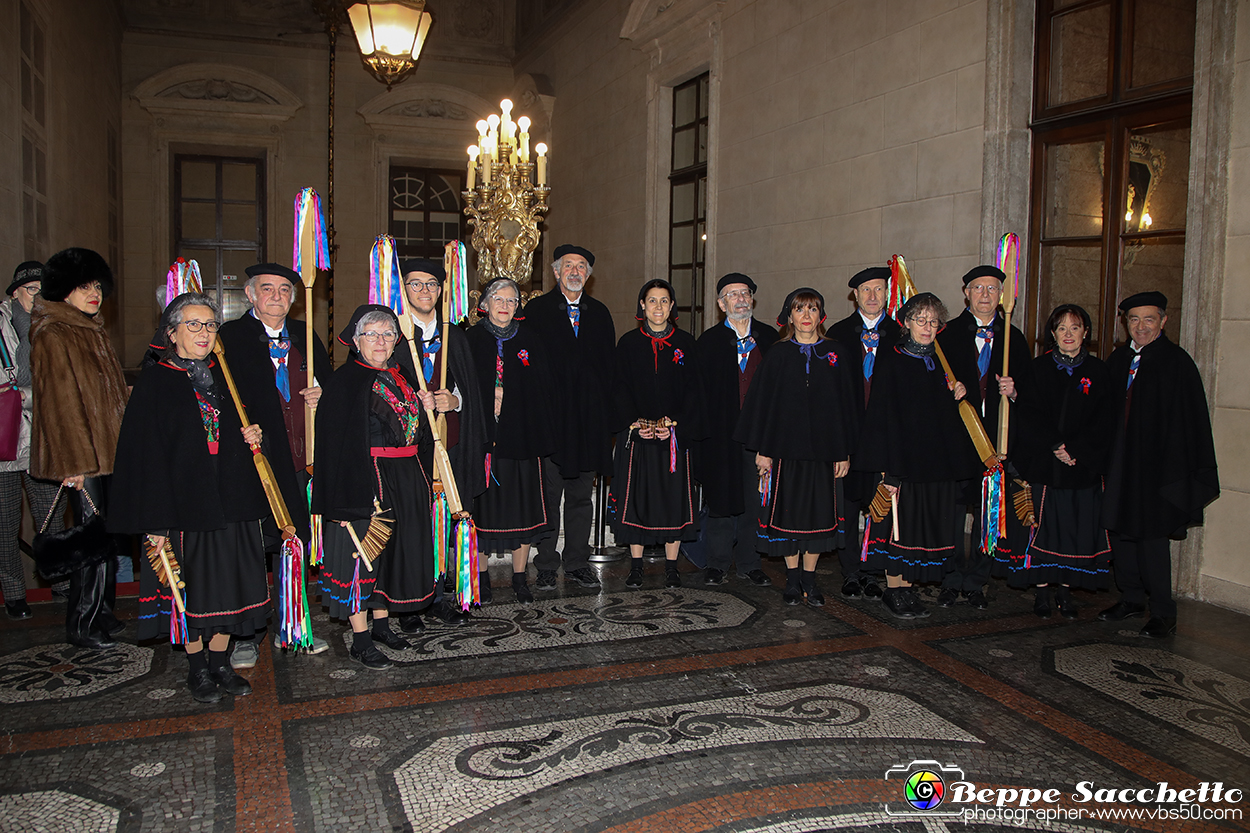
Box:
[759,459,841,555]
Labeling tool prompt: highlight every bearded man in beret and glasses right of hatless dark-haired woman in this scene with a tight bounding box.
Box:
[694,271,778,587]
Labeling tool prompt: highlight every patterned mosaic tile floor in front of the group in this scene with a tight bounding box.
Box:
[0,562,1250,833]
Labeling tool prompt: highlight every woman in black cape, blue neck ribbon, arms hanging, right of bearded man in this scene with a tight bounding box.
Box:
[734,288,859,607]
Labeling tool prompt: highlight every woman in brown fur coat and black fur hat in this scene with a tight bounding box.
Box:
[30,249,126,648]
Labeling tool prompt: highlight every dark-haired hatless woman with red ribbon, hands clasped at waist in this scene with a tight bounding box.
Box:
[610,279,703,587]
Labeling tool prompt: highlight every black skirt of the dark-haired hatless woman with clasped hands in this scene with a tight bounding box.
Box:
[608,432,699,547]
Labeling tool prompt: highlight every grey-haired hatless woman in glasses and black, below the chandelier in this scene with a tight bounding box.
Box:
[469,278,559,604]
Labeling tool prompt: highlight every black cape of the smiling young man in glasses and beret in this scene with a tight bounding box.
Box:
[352,318,494,505]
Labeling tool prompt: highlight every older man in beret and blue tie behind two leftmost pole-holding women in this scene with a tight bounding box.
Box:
[220,263,330,669]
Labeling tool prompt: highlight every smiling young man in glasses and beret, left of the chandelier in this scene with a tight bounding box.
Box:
[395,258,491,620]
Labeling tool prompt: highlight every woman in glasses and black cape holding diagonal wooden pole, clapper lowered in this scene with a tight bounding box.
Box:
[855,293,983,619]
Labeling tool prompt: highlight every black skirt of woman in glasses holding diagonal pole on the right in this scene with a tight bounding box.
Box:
[868,482,963,584]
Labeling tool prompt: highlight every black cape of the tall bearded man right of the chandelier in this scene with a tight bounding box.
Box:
[524,288,616,478]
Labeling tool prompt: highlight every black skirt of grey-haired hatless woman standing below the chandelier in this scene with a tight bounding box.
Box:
[473,454,554,553]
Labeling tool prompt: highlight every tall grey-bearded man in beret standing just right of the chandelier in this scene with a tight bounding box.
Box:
[523,244,616,590]
